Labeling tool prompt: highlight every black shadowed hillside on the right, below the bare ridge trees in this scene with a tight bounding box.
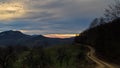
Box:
[75,18,120,64]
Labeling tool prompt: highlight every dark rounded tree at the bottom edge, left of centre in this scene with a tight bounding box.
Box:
[22,46,51,68]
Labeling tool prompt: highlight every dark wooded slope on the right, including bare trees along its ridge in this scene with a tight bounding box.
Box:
[75,0,120,65]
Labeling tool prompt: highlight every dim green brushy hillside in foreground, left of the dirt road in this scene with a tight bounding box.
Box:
[0,45,94,68]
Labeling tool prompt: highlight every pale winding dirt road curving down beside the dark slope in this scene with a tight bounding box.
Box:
[87,46,118,68]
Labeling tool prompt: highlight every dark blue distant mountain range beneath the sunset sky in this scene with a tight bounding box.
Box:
[0,30,73,46]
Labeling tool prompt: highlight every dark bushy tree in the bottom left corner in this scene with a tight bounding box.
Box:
[0,46,16,68]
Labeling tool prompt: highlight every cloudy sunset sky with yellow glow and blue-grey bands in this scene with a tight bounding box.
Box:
[0,0,112,34]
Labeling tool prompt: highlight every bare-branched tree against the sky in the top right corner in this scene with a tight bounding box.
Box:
[104,0,120,21]
